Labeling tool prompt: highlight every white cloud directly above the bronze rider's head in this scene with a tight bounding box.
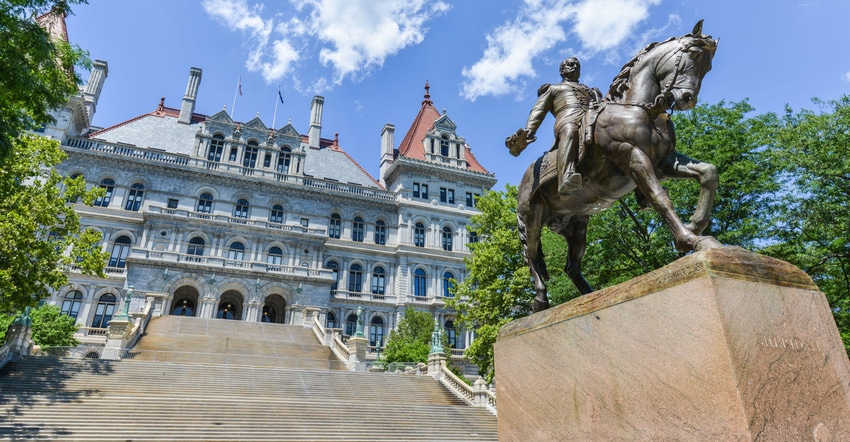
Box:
[461,0,661,101]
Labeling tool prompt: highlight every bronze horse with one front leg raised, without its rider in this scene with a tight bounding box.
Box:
[506,20,722,312]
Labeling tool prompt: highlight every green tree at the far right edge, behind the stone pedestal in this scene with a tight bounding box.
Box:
[764,95,850,352]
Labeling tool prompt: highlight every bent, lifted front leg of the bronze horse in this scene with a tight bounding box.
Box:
[659,152,720,235]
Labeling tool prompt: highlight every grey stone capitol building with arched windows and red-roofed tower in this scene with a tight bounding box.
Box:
[43,27,496,355]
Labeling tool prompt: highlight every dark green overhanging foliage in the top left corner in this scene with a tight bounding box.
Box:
[0,0,90,157]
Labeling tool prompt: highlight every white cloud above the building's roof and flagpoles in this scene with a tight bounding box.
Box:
[203,0,450,90]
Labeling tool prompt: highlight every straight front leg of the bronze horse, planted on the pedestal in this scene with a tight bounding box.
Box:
[619,148,719,252]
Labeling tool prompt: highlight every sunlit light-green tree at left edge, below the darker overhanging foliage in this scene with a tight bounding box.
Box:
[0,135,108,312]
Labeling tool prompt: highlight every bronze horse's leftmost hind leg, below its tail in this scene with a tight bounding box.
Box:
[517,199,549,313]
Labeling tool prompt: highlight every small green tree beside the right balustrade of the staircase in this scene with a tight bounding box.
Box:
[383,307,434,362]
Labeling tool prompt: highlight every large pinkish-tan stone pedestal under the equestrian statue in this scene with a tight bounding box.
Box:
[495,247,850,442]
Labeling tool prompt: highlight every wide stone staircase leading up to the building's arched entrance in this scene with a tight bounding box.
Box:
[0,317,498,442]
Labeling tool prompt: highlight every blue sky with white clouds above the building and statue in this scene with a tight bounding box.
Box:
[67,0,850,189]
